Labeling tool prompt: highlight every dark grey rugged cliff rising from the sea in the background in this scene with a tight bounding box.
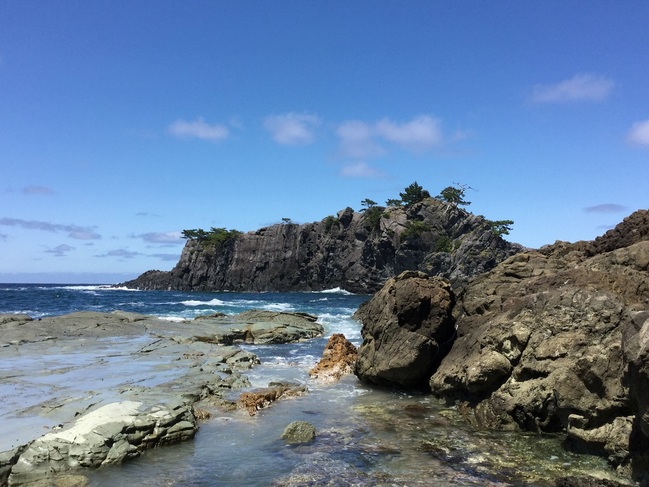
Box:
[124,199,522,293]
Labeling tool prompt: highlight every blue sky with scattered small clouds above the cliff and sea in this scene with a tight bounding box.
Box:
[0,0,649,282]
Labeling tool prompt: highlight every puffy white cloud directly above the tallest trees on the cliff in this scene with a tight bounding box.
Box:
[374,115,443,152]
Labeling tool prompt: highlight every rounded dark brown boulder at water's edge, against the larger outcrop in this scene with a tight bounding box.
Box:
[354,271,455,388]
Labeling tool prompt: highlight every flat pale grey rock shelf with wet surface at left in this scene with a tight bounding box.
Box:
[0,310,323,486]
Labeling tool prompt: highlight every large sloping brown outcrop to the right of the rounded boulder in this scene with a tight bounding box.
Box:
[430,211,649,480]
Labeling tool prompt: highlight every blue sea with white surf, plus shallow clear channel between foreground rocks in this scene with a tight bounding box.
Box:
[0,284,610,487]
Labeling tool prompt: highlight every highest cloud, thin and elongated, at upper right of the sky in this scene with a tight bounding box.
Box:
[531,73,615,103]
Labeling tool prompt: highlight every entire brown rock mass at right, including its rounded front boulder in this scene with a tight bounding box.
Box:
[355,210,649,485]
